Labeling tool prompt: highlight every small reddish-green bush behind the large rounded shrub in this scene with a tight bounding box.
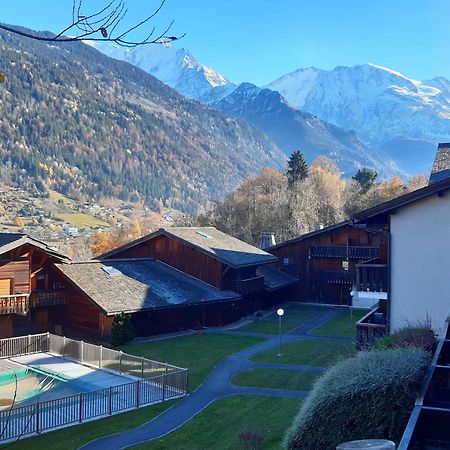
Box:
[373,325,436,353]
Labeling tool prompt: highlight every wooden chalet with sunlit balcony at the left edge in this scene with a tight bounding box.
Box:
[0,233,68,338]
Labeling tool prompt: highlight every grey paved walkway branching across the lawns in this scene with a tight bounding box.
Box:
[81,308,345,450]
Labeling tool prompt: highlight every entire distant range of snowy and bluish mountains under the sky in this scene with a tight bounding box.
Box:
[101,42,450,175]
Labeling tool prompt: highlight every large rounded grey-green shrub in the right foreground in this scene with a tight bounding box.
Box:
[284,347,431,450]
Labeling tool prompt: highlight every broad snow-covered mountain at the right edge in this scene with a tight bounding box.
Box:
[268,64,450,170]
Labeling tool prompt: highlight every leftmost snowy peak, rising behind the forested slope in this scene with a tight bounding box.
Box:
[95,44,236,103]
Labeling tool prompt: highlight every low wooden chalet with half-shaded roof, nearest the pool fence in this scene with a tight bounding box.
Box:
[55,258,242,341]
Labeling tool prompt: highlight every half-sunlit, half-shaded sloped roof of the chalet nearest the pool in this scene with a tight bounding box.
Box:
[55,258,240,314]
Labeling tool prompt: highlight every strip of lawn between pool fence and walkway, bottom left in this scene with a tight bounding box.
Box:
[0,400,177,450]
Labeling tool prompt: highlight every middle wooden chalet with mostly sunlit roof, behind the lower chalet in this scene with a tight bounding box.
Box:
[99,227,296,313]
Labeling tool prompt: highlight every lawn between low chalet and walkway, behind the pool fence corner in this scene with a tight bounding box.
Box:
[121,333,264,391]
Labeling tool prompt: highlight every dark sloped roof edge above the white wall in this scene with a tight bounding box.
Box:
[354,178,450,222]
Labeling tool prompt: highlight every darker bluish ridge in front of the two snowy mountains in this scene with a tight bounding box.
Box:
[212,83,402,176]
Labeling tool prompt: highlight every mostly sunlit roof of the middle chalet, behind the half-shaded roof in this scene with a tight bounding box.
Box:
[99,227,278,268]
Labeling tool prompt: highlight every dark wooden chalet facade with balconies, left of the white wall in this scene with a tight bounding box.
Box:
[268,222,388,305]
